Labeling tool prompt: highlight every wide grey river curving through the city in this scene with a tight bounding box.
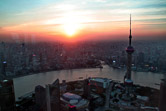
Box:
[13,65,164,98]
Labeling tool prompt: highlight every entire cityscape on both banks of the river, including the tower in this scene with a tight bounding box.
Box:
[0,17,166,111]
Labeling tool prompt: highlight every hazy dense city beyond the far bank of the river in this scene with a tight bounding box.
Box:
[0,41,166,77]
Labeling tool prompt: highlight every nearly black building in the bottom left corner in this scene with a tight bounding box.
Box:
[0,80,15,111]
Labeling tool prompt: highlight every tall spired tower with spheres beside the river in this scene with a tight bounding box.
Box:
[124,14,134,86]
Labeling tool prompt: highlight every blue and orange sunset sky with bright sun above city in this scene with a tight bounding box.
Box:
[0,0,166,41]
